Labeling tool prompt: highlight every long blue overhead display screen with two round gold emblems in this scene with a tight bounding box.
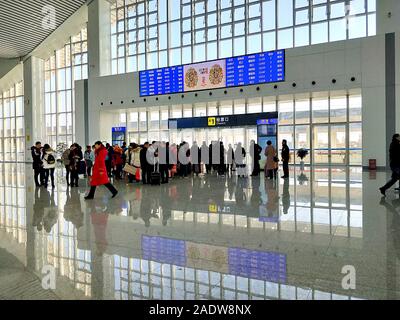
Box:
[139,50,285,97]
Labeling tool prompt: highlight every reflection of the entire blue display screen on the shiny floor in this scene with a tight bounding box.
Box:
[142,235,287,283]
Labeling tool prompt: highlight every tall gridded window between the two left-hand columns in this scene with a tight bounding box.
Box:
[44,28,88,148]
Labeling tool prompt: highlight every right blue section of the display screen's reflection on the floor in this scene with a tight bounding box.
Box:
[228,248,287,283]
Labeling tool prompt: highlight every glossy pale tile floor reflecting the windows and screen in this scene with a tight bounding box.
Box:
[0,164,400,300]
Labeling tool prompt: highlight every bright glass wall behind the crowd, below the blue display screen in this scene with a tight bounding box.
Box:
[115,92,362,166]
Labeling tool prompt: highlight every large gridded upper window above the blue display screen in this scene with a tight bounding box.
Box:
[111,0,376,74]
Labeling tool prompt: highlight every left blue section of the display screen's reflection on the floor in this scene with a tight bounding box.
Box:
[142,235,186,267]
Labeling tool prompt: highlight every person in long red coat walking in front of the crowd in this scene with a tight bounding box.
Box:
[85,141,118,200]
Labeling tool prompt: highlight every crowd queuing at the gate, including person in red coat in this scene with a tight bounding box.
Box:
[31,140,290,200]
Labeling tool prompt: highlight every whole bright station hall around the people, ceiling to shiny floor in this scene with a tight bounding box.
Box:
[0,0,400,300]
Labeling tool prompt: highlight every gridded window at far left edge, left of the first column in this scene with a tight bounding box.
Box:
[0,81,25,162]
